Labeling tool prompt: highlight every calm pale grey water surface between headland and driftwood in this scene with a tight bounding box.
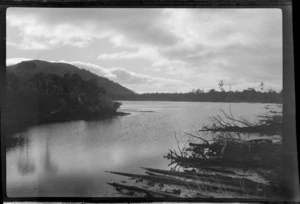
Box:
[6,101,275,197]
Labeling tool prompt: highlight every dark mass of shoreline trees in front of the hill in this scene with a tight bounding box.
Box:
[5,73,122,147]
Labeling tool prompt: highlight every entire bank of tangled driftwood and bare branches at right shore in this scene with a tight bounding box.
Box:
[108,106,282,201]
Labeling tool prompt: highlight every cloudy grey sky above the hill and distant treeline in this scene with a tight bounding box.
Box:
[6,8,282,93]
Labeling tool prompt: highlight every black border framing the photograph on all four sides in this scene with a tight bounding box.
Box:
[0,0,300,203]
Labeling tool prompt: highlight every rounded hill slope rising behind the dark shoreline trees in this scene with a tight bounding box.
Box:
[7,60,134,95]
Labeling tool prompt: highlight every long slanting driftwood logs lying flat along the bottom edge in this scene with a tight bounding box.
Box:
[108,168,274,198]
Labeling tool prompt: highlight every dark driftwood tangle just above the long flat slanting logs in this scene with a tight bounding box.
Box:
[165,138,281,169]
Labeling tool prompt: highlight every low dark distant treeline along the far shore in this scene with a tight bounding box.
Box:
[113,89,282,103]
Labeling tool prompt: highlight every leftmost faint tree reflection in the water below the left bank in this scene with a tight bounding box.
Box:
[18,139,36,175]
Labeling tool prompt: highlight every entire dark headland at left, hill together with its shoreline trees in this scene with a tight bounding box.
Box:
[5,60,133,148]
